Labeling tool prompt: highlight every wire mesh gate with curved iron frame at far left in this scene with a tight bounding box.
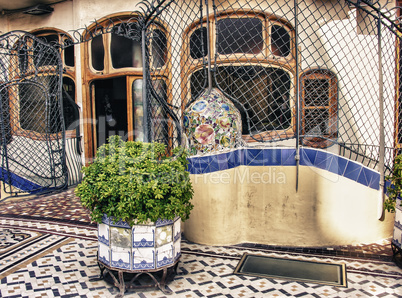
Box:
[0,32,67,193]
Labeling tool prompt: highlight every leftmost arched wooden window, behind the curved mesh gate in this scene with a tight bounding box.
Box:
[2,28,79,139]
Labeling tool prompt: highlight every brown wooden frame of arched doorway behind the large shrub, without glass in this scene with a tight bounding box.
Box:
[81,12,172,158]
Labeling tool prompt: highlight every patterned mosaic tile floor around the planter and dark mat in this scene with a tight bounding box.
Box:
[0,189,402,297]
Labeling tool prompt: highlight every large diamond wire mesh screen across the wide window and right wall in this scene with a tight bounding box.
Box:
[142,0,402,173]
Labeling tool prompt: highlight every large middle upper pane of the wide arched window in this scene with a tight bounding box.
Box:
[217,18,264,54]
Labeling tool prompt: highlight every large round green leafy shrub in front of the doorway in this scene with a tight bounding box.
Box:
[75,136,193,224]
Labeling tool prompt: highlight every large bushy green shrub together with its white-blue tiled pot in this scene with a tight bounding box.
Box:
[75,136,193,271]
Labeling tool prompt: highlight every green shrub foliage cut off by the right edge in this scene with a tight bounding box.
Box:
[384,155,402,212]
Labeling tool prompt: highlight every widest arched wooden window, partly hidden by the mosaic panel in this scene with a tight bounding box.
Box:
[182,11,295,142]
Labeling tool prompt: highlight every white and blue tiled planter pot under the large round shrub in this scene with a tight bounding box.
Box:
[98,216,181,271]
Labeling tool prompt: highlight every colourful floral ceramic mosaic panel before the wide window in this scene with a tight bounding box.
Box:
[183,88,242,155]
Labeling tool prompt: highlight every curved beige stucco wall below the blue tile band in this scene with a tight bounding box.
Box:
[184,166,394,246]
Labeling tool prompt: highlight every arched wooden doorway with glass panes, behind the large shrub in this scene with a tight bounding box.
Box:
[83,13,171,157]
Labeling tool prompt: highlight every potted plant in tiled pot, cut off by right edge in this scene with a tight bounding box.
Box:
[384,155,402,268]
